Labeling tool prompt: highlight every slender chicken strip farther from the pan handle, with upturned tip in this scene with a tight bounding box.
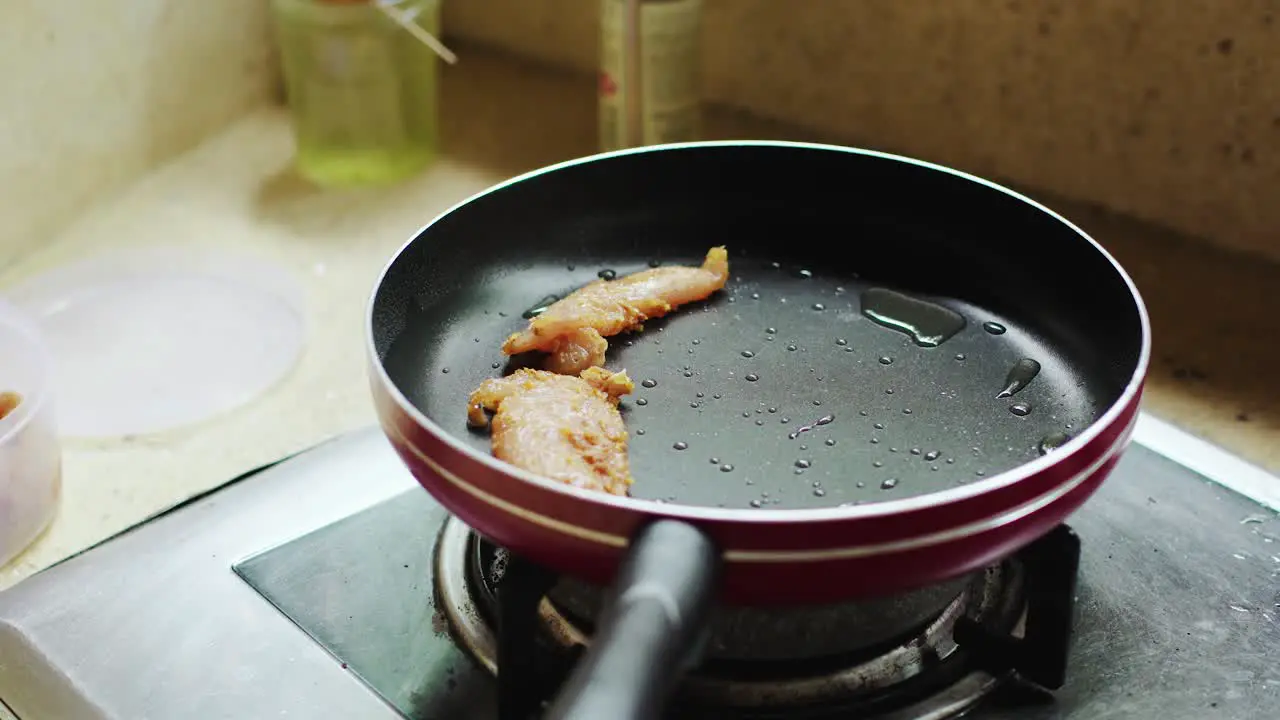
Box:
[502,247,728,375]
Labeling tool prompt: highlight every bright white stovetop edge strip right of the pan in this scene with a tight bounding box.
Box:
[1133,413,1280,512]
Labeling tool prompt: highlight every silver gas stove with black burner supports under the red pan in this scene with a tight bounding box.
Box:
[0,416,1280,720]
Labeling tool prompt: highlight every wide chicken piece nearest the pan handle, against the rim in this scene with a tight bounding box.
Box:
[467,368,635,495]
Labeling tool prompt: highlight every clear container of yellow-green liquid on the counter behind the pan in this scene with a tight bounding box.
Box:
[273,0,440,187]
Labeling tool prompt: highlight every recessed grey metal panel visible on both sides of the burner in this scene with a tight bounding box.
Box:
[230,446,1280,720]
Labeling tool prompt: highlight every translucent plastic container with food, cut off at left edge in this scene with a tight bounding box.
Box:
[0,301,63,565]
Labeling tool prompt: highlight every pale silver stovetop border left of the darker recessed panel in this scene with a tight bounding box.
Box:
[0,429,413,720]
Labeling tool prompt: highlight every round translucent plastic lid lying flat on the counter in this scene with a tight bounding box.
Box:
[10,247,306,437]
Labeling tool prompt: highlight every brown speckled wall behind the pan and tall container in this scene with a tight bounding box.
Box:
[445,0,1280,258]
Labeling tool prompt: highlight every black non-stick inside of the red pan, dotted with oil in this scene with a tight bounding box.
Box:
[374,146,1142,507]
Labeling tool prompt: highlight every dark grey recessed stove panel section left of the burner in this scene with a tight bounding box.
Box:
[236,489,495,720]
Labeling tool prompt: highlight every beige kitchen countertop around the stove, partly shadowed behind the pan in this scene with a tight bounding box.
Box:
[0,47,1280,588]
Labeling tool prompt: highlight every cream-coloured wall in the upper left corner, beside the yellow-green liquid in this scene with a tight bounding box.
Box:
[0,0,274,266]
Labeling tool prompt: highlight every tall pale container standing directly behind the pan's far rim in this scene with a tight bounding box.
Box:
[599,0,703,150]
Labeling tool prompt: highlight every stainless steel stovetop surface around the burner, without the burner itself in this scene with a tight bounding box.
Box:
[0,416,1280,720]
